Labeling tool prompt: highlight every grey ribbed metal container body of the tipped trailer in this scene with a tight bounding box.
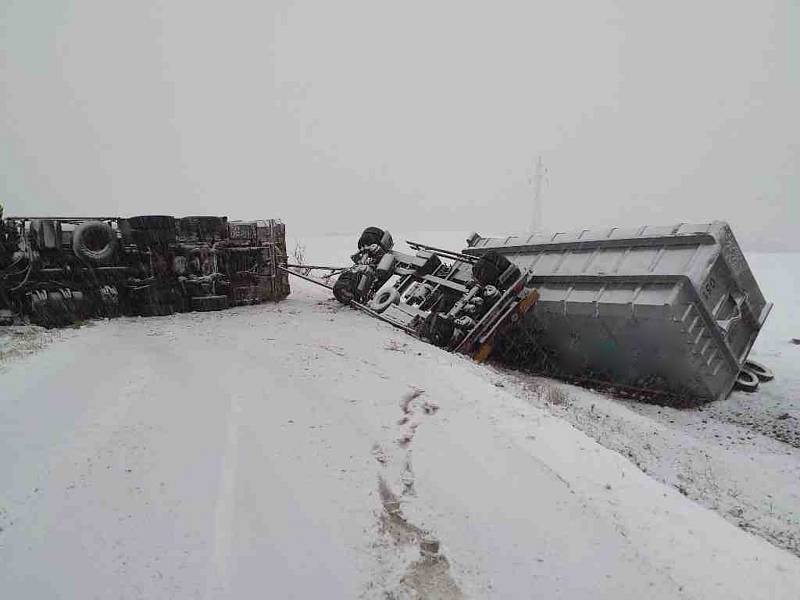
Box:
[464,221,772,400]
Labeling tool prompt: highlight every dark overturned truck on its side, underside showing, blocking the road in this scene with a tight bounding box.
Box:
[0,215,289,327]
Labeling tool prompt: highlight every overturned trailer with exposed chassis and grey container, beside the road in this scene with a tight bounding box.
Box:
[316,222,772,404]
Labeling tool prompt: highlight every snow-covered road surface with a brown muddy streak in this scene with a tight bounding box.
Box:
[0,281,800,600]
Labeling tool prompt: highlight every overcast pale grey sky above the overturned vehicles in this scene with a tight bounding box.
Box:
[0,0,800,247]
